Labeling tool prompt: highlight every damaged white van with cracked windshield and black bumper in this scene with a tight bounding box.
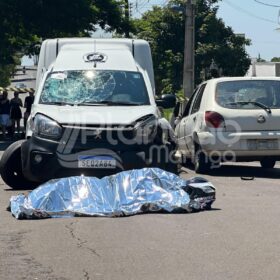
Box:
[0,38,176,188]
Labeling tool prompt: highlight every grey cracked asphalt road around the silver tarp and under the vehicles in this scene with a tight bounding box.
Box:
[0,154,280,280]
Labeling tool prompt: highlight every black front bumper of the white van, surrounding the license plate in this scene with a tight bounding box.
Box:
[21,137,161,183]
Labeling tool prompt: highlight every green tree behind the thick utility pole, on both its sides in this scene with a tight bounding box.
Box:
[134,0,250,94]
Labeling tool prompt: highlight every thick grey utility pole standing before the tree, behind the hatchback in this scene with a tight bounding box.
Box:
[183,0,195,98]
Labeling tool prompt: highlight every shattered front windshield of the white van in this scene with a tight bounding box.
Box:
[40,70,150,105]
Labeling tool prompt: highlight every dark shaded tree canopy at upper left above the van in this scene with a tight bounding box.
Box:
[0,0,128,85]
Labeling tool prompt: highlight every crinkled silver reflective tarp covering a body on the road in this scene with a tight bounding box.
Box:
[10,168,215,219]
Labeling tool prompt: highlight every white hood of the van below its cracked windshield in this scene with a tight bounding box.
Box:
[31,104,159,125]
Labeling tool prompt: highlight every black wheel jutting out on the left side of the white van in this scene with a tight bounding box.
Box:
[0,140,35,189]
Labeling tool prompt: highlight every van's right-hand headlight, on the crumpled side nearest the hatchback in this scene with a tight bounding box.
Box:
[134,116,158,142]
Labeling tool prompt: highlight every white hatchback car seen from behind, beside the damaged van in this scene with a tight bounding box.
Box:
[175,77,280,173]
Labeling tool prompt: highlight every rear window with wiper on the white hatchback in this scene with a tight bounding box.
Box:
[216,80,280,109]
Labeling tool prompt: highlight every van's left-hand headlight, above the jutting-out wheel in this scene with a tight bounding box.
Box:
[31,114,62,140]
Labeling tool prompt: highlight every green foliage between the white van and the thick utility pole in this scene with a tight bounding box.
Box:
[135,4,184,94]
